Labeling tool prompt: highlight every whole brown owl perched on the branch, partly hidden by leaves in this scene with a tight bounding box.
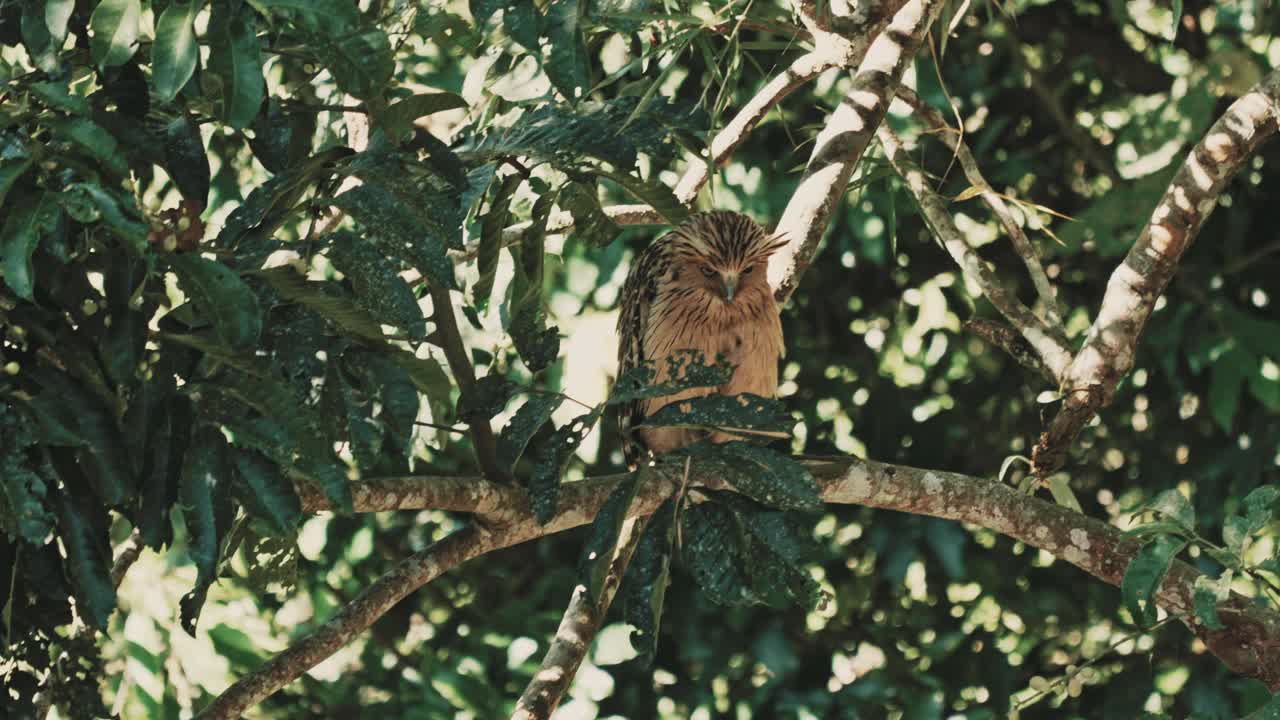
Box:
[618,211,783,468]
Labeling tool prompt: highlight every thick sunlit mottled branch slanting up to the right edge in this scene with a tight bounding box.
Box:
[1032,65,1280,477]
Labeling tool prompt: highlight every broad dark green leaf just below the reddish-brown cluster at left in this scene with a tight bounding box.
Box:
[169,255,262,350]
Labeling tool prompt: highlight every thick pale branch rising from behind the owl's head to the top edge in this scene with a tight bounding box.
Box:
[769,0,942,302]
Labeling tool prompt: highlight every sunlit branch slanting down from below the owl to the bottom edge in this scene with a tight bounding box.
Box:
[511,515,652,720]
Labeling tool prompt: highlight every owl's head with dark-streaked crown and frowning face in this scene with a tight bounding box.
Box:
[664,210,786,304]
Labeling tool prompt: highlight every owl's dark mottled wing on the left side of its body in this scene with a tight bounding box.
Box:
[618,240,666,468]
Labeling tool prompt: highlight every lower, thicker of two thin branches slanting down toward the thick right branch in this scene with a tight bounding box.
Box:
[877,126,1071,383]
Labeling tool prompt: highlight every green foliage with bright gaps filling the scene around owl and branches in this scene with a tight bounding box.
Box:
[0,0,1280,720]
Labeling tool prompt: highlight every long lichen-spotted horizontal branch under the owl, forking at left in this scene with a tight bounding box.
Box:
[200,457,1280,719]
